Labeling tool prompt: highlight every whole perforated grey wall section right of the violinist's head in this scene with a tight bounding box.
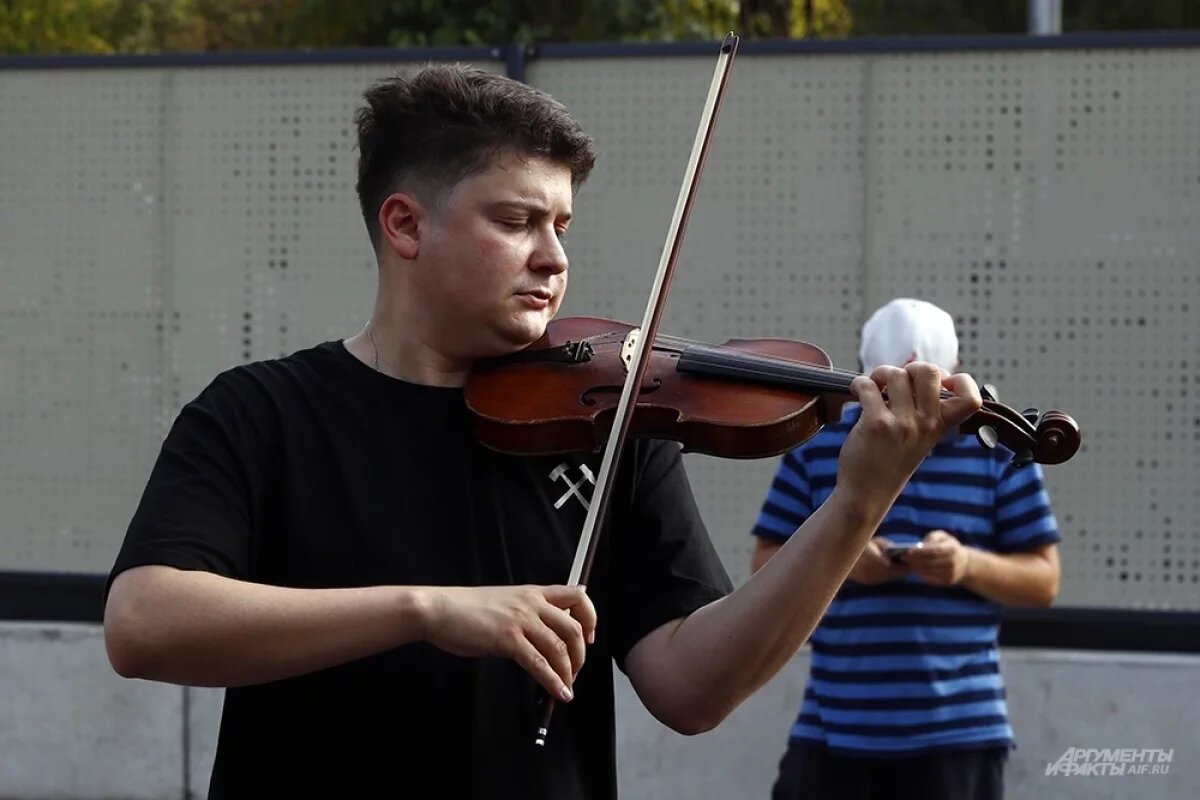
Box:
[530,50,1200,608]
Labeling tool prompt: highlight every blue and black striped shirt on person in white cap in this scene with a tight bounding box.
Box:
[754,404,1060,757]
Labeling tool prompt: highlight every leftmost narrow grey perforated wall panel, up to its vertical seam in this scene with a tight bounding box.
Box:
[0,71,164,570]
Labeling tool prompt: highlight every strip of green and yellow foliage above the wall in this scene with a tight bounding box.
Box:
[7,0,1200,54]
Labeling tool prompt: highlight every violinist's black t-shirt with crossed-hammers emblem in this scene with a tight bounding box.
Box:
[109,342,731,800]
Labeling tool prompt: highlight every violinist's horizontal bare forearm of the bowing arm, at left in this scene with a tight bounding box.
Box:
[104,567,422,686]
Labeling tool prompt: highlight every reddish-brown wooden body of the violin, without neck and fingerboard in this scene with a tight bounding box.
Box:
[466,317,852,458]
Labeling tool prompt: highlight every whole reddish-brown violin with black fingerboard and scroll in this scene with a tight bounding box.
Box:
[466,317,1080,465]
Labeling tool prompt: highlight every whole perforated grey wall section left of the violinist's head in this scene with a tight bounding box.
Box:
[0,64,497,571]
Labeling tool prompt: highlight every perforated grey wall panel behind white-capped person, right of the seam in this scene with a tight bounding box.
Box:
[865,49,1200,608]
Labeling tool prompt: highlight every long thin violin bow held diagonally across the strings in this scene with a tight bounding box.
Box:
[534,31,739,747]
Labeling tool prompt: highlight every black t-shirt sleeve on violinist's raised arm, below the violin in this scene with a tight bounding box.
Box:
[611,441,733,670]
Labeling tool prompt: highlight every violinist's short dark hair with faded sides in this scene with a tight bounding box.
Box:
[354,65,596,243]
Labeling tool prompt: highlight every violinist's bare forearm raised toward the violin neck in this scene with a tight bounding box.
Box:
[636,484,887,732]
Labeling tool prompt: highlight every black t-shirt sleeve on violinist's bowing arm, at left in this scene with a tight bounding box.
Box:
[104,369,275,600]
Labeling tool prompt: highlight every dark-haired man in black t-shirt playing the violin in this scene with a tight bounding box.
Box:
[104,67,980,799]
